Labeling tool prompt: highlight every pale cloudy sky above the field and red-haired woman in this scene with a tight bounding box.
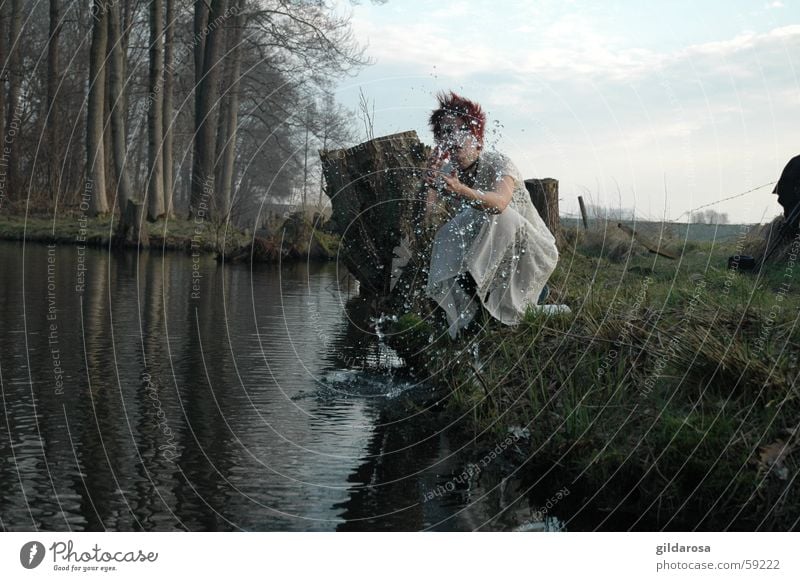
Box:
[330,0,800,223]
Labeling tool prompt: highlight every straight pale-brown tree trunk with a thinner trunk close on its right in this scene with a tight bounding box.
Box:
[147,0,164,221]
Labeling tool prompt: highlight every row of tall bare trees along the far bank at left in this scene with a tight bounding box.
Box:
[0,0,370,223]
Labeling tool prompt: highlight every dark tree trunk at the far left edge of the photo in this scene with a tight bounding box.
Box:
[2,0,22,200]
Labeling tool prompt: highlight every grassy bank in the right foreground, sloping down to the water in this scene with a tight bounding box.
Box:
[384,227,800,530]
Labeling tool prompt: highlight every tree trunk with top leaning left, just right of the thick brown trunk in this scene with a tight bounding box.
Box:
[108,3,132,211]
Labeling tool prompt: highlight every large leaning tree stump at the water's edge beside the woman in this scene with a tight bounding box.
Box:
[320,131,428,297]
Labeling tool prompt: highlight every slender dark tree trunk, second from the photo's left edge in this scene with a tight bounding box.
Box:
[46,0,62,207]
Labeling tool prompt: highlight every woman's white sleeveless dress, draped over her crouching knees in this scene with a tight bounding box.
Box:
[426,151,558,338]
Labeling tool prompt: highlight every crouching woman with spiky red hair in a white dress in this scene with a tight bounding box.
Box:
[425,92,558,339]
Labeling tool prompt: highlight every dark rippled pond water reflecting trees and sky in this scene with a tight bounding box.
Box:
[0,242,536,531]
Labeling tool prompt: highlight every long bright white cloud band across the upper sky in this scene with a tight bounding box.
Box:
[353,3,800,82]
